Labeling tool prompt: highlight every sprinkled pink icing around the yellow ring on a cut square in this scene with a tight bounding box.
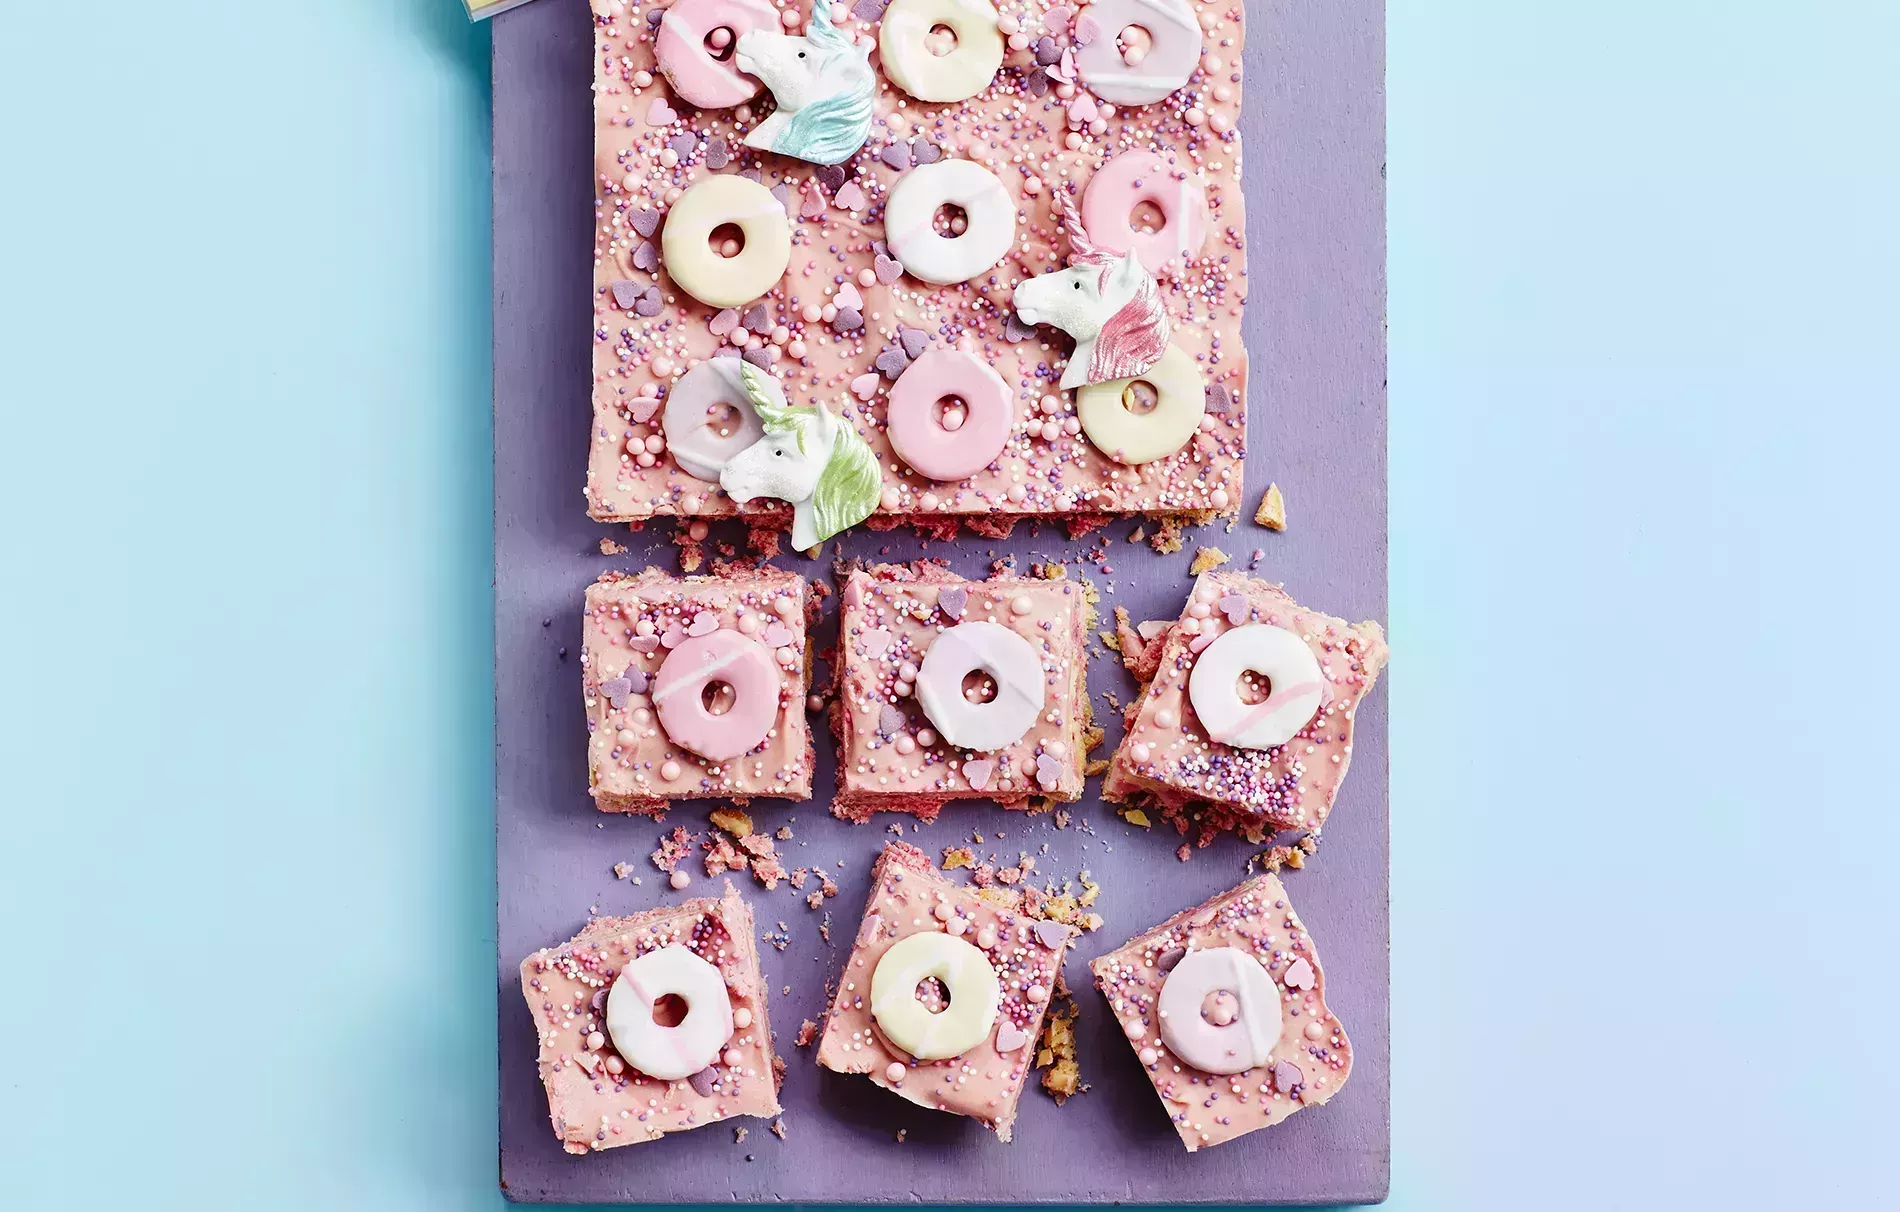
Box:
[817,842,1072,1140]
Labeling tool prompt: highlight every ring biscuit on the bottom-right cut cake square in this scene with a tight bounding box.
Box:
[1155,946,1284,1073]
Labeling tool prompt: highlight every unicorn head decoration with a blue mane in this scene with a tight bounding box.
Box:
[733,2,878,163]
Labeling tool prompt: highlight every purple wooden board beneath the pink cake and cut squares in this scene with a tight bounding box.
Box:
[494,0,1404,1204]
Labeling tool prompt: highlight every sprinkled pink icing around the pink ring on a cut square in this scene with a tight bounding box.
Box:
[581,568,815,815]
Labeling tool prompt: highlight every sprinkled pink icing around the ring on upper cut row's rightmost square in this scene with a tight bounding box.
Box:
[1102,572,1387,832]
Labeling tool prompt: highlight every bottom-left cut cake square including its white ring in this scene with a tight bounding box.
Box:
[521,883,779,1153]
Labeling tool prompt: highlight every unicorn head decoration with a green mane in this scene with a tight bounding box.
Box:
[718,363,882,551]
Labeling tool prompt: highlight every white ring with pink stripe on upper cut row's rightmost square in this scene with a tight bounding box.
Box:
[1188,623,1326,748]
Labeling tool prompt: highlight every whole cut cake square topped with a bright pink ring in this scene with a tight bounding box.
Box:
[581,568,817,817]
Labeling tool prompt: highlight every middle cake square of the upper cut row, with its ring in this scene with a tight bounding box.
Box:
[830,562,1094,821]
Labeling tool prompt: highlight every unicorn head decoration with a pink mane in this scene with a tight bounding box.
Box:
[1015,198,1172,388]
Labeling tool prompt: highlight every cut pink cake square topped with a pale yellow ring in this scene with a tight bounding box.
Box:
[819,842,1074,1142]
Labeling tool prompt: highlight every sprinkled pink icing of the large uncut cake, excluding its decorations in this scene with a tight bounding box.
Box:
[587,0,1248,530]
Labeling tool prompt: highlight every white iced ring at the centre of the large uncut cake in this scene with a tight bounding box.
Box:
[884,160,1017,287]
